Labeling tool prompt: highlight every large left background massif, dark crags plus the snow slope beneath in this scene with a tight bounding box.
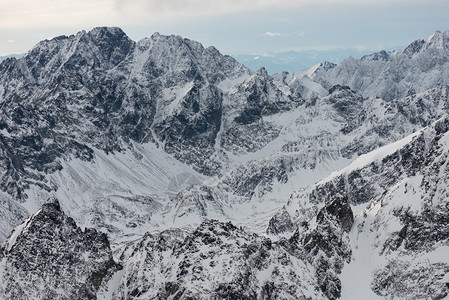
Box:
[0,28,298,244]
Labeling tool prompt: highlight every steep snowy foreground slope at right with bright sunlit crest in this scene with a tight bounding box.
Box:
[273,118,449,299]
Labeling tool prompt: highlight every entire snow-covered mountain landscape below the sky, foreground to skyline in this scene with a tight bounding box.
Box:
[0,27,449,299]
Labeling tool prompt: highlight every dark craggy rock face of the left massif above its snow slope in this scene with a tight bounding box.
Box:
[0,28,249,199]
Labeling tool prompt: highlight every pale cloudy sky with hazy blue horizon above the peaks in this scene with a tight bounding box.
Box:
[0,0,449,56]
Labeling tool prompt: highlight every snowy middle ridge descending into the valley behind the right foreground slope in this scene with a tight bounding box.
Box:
[163,86,449,231]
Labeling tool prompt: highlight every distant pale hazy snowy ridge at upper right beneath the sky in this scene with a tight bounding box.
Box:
[300,31,449,101]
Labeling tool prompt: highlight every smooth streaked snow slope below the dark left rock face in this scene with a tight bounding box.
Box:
[20,144,204,247]
